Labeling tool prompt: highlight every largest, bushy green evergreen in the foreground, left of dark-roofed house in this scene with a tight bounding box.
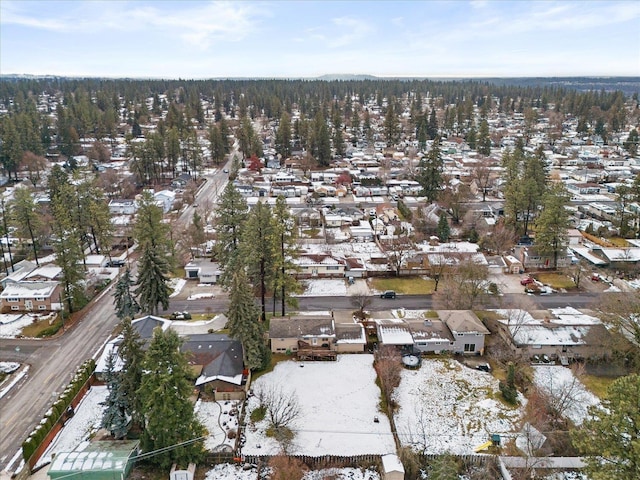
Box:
[138,327,205,468]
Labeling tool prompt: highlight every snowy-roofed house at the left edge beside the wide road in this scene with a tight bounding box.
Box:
[0,282,61,312]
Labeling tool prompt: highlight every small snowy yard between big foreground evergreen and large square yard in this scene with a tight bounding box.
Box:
[195,400,239,452]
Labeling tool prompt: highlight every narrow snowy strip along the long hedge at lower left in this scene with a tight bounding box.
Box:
[38,385,107,465]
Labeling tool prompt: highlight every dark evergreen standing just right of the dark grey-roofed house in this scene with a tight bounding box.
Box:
[227,270,270,370]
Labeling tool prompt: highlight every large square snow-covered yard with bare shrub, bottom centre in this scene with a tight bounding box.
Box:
[242,355,395,455]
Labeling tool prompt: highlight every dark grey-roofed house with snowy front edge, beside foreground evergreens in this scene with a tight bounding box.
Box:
[181,333,250,400]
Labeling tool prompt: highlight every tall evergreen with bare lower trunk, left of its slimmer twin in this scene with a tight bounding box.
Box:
[240,202,276,322]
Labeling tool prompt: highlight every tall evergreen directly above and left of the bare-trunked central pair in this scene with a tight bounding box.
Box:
[214,182,247,287]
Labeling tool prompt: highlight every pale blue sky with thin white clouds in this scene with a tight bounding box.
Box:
[0,0,640,79]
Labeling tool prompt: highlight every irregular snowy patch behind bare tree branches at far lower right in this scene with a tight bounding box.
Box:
[533,365,600,425]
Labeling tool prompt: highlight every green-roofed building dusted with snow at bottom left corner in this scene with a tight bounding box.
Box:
[47,440,139,480]
